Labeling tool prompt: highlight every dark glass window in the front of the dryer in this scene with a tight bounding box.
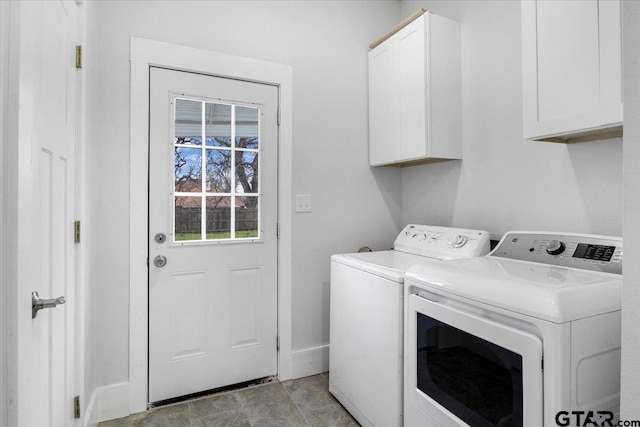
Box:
[416,313,523,427]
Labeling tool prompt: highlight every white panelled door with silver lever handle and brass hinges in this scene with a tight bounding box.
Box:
[7,0,77,427]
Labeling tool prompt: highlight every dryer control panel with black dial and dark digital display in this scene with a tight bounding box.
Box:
[490,231,622,274]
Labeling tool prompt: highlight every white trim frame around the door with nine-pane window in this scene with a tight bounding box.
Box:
[129,37,293,413]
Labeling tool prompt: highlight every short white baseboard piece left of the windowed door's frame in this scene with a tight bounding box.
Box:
[84,382,129,427]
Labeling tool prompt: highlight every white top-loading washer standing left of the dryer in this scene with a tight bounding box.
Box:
[329,224,489,427]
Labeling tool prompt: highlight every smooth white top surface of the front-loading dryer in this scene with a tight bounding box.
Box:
[405,257,622,323]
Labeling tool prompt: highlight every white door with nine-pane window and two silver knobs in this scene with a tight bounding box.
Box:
[149,67,278,402]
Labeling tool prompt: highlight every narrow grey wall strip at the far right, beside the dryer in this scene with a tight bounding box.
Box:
[621,0,640,420]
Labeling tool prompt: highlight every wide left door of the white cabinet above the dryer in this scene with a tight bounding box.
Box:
[522,0,601,138]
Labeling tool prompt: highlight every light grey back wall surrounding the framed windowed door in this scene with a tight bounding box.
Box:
[86,0,402,399]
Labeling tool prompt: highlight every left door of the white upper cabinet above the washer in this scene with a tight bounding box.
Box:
[369,39,400,166]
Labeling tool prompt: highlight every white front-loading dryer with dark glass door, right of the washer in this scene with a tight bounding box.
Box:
[404,232,622,427]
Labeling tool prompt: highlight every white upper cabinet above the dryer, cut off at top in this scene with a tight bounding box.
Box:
[522,0,622,142]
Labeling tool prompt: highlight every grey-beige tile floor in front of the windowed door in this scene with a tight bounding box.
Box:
[99,373,359,427]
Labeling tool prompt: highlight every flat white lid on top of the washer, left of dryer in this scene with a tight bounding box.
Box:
[331,250,434,283]
